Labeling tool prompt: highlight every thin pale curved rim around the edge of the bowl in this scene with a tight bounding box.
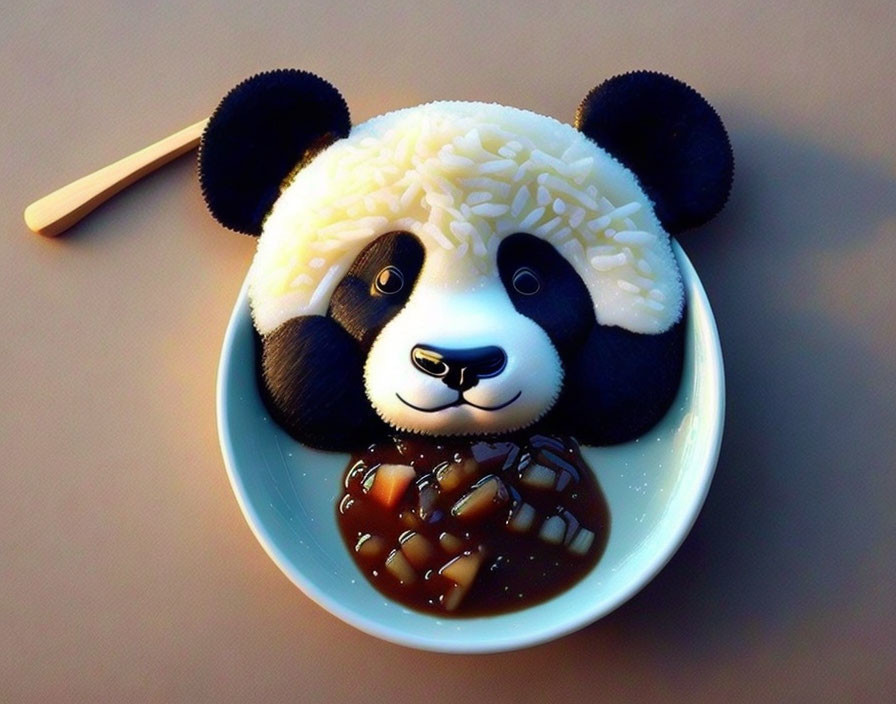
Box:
[216,239,725,653]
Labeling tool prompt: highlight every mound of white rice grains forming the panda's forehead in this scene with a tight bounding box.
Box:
[249,102,684,334]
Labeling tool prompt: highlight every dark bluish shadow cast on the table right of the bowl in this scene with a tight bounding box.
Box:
[581,114,896,651]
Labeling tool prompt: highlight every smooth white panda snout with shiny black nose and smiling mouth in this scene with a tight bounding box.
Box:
[364,280,564,436]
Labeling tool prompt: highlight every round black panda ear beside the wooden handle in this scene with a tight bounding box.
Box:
[199,69,351,235]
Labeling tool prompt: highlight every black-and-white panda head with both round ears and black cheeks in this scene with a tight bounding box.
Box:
[200,70,732,449]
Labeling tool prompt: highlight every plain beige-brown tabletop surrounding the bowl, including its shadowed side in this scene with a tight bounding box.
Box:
[0,0,896,702]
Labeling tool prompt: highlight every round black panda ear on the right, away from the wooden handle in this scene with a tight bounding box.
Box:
[575,71,734,234]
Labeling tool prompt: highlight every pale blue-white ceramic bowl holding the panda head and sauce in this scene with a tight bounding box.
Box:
[218,243,725,653]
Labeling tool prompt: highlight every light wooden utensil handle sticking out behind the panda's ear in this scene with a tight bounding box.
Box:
[25,119,208,237]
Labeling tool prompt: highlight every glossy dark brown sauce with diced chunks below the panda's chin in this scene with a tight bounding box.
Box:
[337,435,610,616]
